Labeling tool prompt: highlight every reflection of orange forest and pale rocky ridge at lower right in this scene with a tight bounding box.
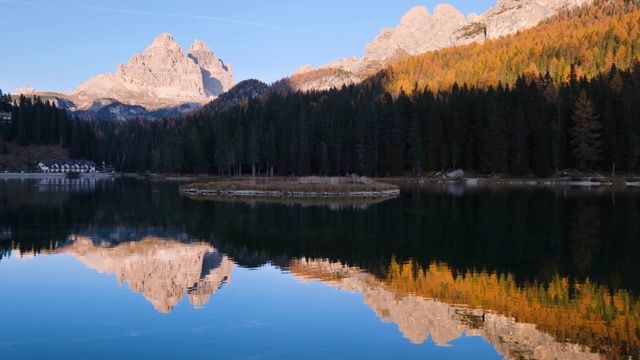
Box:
[290,259,640,359]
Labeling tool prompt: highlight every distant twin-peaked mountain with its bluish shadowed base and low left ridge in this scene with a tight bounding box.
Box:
[21,33,236,120]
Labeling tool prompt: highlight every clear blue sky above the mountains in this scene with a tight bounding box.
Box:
[0,0,496,92]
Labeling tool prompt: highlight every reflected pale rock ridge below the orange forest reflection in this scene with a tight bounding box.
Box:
[289,258,600,359]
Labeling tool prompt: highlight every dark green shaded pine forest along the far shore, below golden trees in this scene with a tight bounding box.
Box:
[2,68,640,176]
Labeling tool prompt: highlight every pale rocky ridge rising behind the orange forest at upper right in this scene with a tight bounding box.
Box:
[291,0,593,91]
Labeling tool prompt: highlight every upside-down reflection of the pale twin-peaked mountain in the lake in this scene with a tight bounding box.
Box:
[60,237,235,313]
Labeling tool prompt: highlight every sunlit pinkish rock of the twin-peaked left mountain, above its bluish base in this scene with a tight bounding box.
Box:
[65,34,236,118]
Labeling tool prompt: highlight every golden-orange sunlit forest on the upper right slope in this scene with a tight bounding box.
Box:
[375,0,640,95]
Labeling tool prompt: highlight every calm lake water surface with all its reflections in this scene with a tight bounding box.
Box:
[0,179,640,359]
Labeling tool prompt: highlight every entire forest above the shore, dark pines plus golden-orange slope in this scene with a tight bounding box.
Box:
[2,0,640,177]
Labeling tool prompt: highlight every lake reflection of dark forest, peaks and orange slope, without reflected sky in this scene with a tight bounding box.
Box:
[0,182,640,358]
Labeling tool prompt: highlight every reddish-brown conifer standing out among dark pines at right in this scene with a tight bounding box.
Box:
[569,89,602,170]
